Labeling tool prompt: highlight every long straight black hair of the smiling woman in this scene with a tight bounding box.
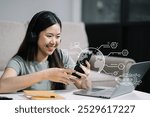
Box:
[16,11,66,90]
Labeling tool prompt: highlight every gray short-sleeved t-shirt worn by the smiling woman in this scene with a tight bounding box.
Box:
[6,50,75,90]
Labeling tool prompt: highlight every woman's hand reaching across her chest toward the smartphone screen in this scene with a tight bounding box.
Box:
[44,68,73,85]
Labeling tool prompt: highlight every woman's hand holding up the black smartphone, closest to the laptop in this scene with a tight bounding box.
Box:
[70,61,91,89]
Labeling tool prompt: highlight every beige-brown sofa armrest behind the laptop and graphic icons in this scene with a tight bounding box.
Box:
[90,56,135,76]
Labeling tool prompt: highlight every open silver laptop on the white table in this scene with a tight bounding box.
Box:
[73,61,150,99]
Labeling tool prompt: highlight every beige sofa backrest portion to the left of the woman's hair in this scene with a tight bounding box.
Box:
[0,21,26,70]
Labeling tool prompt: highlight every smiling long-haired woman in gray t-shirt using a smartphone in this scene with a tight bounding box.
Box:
[0,11,90,93]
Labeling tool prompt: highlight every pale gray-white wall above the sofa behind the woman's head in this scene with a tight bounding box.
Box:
[0,0,82,22]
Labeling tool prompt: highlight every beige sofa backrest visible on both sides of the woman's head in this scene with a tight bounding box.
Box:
[0,21,88,71]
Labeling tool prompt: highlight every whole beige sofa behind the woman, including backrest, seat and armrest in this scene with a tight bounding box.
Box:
[0,21,135,86]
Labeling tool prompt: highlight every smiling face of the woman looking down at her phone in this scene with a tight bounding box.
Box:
[37,24,61,60]
